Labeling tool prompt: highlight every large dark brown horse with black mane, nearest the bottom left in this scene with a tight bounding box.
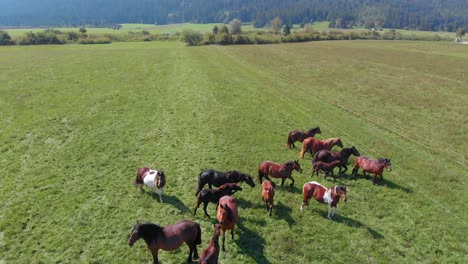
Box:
[128,220,201,264]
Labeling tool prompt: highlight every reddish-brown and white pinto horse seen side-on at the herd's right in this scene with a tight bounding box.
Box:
[301,181,348,219]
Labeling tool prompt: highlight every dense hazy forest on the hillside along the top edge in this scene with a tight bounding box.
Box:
[0,0,468,31]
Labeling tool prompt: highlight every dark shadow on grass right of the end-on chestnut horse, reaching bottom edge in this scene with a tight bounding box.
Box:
[235,221,271,264]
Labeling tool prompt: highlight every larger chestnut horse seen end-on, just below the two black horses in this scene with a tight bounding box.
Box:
[216,196,239,251]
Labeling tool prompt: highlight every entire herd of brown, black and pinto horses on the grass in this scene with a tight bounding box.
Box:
[128,127,392,263]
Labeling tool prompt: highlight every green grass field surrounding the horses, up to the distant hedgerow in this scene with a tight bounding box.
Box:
[0,41,468,263]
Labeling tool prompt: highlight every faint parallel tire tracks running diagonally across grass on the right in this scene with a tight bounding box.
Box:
[216,46,468,226]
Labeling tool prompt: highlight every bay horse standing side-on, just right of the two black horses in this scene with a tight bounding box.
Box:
[258,160,302,186]
